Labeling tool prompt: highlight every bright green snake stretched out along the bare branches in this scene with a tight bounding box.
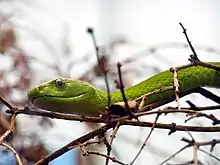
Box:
[28,62,220,116]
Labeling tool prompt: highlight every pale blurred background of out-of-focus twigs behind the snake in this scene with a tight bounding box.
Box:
[0,0,220,165]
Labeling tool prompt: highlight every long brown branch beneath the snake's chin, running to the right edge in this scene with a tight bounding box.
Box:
[6,107,220,132]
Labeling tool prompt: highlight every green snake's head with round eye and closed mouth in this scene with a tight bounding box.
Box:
[28,78,98,113]
